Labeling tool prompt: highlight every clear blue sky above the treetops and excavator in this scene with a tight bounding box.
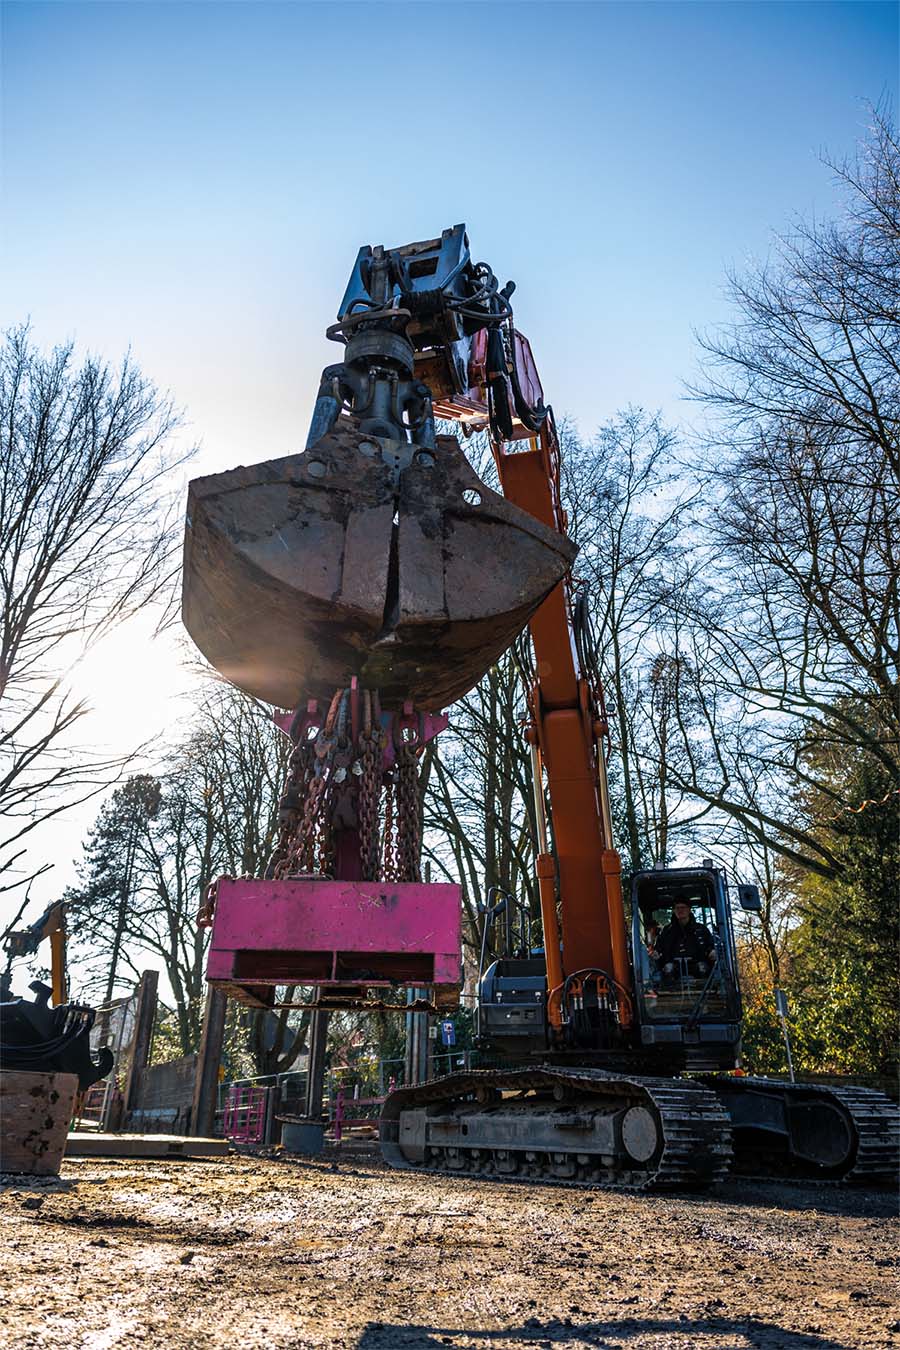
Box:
[0,0,899,945]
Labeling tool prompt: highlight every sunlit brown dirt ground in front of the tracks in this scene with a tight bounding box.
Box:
[0,1156,900,1350]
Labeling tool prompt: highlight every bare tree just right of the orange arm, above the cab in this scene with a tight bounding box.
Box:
[563,408,702,868]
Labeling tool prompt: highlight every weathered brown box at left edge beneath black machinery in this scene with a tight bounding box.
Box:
[0,1069,78,1176]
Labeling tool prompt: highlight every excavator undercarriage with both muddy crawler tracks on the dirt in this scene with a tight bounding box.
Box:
[381,1065,899,1191]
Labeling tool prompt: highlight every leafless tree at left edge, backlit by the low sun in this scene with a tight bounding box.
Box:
[0,327,190,890]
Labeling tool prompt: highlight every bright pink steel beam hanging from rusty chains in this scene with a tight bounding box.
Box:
[206,876,461,987]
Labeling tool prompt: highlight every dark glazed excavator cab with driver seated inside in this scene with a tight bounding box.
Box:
[631,863,741,1069]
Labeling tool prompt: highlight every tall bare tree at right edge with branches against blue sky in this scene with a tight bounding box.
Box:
[679,108,900,878]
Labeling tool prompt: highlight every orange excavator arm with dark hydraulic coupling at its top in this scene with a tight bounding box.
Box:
[330,225,631,1031]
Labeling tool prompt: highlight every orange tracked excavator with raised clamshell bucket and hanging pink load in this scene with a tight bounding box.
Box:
[182,224,897,1189]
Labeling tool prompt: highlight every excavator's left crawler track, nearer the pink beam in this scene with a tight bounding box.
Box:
[381,1065,731,1191]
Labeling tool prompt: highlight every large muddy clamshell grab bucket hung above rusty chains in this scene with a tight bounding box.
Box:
[182,419,576,709]
